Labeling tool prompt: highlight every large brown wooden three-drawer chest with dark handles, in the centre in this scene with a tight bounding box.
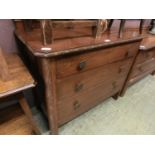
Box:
[16,28,142,134]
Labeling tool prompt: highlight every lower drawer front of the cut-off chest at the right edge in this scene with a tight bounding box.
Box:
[131,58,155,78]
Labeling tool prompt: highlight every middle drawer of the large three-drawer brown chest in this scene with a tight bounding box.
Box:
[57,58,133,100]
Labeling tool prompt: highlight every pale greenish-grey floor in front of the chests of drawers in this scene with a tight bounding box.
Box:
[60,75,155,135]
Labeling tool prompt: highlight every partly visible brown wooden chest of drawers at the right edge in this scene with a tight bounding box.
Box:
[121,34,155,96]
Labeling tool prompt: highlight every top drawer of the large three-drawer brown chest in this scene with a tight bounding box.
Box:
[56,42,139,78]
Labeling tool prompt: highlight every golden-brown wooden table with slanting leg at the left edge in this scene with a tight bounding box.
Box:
[0,48,40,134]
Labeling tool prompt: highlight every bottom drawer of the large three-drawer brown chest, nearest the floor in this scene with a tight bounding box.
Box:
[57,74,124,125]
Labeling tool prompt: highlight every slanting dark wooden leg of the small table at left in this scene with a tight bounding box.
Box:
[18,93,41,134]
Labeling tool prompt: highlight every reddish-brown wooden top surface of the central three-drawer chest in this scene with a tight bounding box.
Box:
[15,30,143,57]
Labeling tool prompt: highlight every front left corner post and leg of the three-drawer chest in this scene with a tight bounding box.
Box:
[41,58,58,134]
